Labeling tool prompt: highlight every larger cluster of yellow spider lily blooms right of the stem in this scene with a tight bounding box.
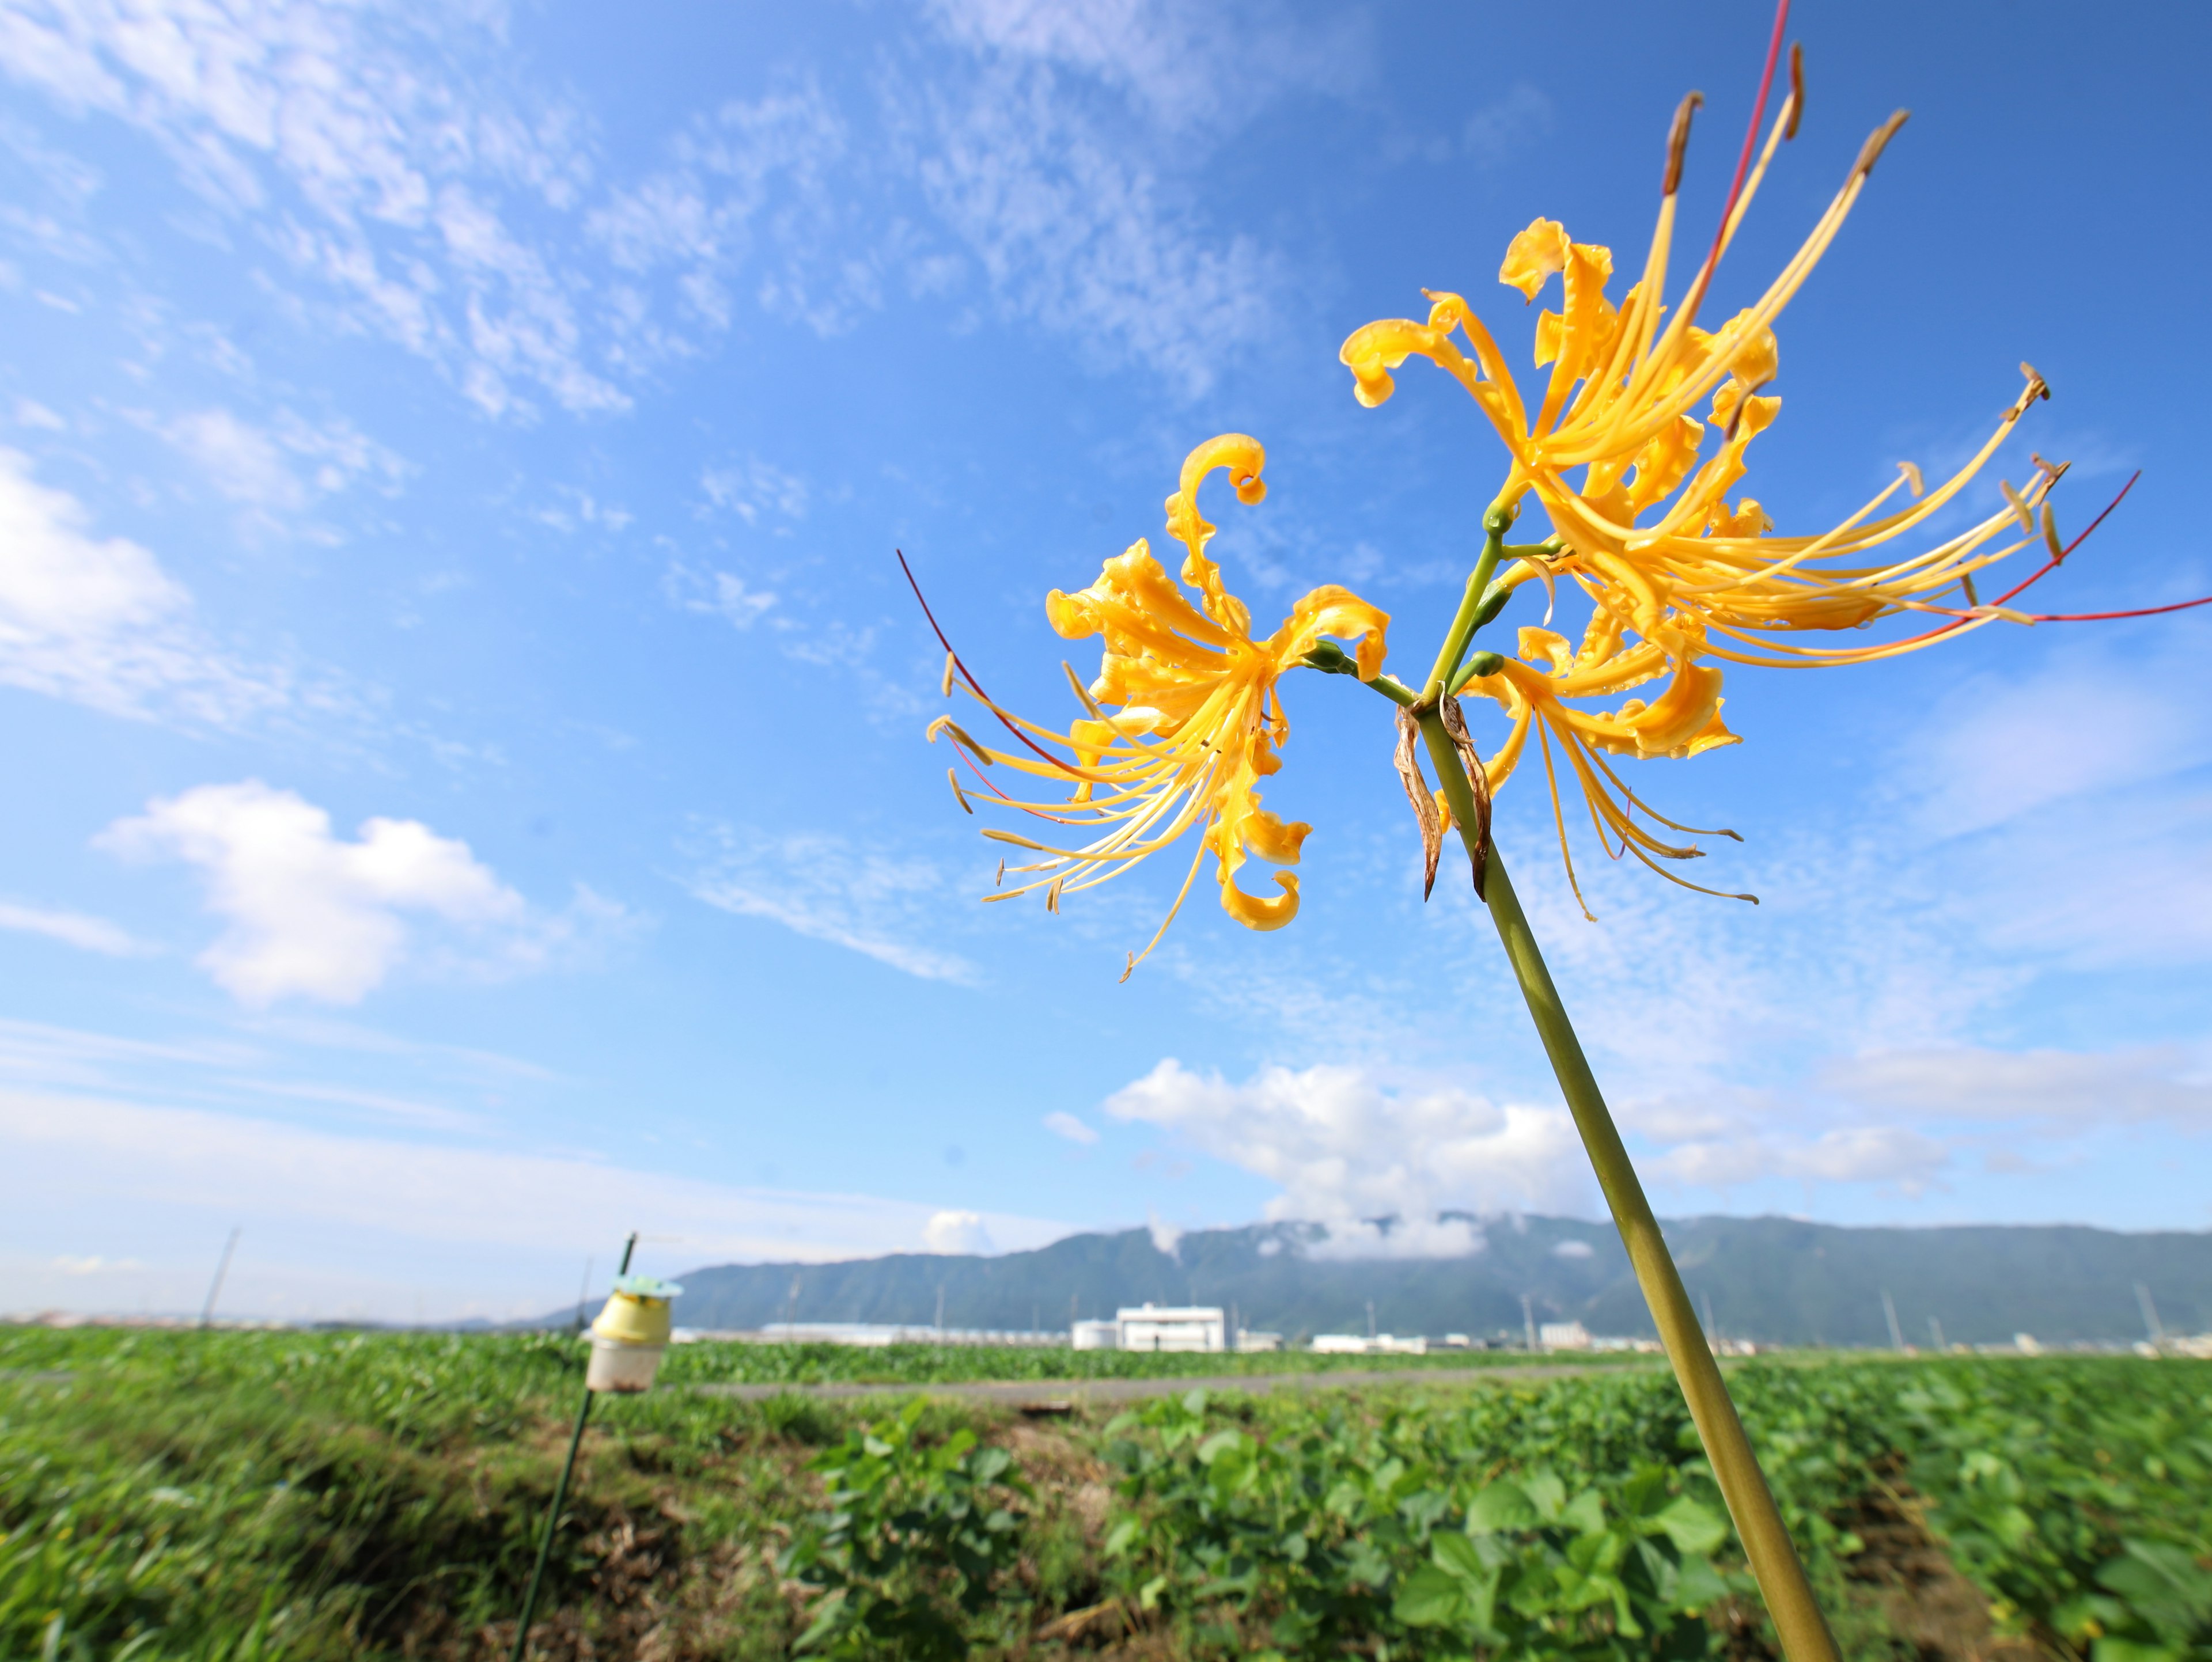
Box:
[1338,86,2064,915]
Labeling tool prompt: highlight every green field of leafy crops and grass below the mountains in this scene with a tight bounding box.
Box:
[0,1328,2212,1662]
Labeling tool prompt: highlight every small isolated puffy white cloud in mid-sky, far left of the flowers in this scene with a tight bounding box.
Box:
[97,780,529,1005]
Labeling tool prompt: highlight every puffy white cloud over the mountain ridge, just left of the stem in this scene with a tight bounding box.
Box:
[1106,1058,1593,1255]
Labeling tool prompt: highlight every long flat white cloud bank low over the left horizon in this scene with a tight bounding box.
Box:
[0,1090,1069,1319]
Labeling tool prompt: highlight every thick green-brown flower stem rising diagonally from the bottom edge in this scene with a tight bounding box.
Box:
[1393,699,1840,1662]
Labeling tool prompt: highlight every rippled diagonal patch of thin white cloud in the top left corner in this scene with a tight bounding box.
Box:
[0,0,626,413]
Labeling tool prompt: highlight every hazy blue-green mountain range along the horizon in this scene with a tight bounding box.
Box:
[646,1216,2212,1346]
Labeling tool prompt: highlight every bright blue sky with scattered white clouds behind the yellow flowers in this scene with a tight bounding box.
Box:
[0,0,2212,1317]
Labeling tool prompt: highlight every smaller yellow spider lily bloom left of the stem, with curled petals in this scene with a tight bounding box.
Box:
[929,433,1389,979]
